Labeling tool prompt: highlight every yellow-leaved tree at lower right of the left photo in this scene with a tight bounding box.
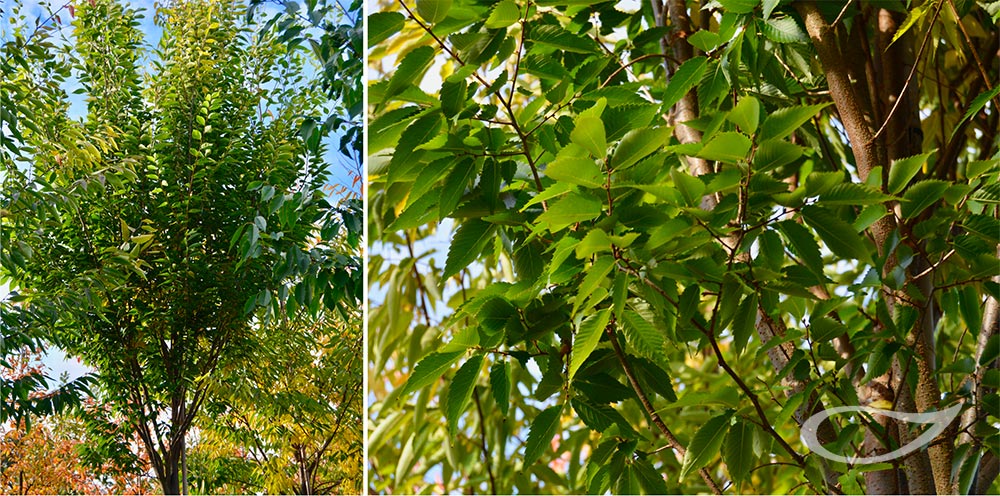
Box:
[192,304,363,494]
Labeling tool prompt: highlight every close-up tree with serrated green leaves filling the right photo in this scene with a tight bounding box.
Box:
[368,0,1000,494]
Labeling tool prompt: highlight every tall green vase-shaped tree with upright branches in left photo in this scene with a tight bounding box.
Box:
[0,0,361,494]
